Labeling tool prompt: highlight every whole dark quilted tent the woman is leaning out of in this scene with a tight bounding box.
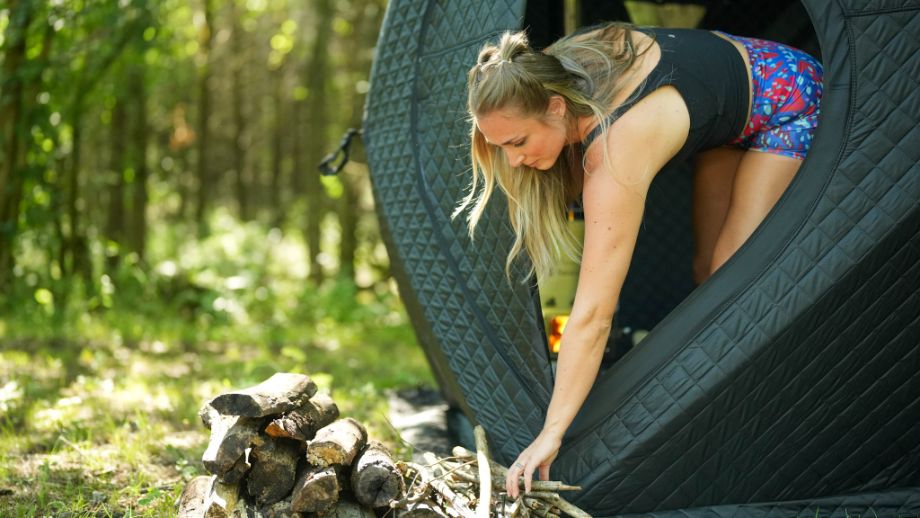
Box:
[365,0,920,517]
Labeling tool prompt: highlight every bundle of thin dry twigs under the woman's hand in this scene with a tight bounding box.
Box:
[390,427,590,518]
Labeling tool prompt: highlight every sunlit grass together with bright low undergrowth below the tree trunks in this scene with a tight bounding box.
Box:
[0,210,434,516]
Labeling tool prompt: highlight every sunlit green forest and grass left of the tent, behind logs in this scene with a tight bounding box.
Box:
[0,0,433,516]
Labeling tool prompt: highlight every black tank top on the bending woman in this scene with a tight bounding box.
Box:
[582,27,751,162]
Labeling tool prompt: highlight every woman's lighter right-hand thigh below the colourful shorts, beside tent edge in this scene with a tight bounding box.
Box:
[712,151,802,271]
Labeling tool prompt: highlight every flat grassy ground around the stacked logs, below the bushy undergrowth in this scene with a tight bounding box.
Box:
[0,283,433,517]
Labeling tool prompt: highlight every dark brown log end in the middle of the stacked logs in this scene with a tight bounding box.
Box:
[246,437,300,506]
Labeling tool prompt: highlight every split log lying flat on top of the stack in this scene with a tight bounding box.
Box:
[209,372,316,417]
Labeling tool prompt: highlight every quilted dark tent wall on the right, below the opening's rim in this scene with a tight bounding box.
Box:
[569,3,920,512]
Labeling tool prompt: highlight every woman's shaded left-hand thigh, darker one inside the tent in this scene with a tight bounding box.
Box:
[693,147,745,284]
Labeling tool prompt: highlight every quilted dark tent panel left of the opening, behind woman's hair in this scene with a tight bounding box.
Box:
[365,1,552,464]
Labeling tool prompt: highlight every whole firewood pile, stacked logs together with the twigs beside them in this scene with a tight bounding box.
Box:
[176,373,588,518]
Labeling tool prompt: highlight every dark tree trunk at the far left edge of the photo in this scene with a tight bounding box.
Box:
[0,0,32,292]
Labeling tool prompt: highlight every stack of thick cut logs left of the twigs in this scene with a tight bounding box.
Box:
[176,373,405,518]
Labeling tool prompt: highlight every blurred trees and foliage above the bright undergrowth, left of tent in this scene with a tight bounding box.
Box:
[0,0,385,308]
